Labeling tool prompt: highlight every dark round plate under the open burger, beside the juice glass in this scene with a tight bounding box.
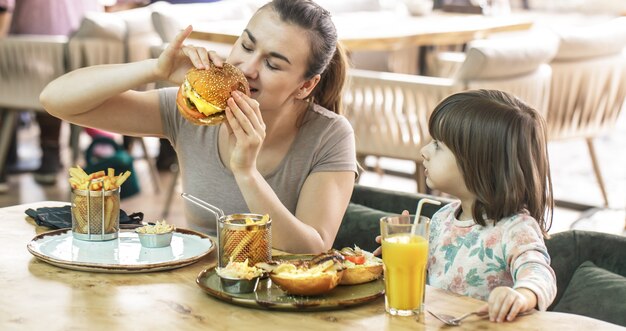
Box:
[196,255,385,310]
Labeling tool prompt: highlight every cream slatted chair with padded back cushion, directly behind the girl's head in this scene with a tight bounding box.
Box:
[345,33,557,192]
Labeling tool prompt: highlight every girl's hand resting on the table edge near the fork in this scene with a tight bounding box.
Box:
[479,286,536,323]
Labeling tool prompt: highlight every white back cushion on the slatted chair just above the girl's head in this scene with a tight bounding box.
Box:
[456,32,558,81]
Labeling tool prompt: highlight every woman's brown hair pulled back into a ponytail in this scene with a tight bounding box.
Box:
[261,0,348,114]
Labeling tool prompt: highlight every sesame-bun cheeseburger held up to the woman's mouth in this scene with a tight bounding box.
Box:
[176,63,250,125]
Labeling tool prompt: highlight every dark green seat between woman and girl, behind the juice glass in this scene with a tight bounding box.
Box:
[333,184,453,252]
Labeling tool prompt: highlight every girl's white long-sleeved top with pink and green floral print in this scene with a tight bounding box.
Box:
[428,202,556,310]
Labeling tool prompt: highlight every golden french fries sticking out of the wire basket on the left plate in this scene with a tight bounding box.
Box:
[69,166,130,191]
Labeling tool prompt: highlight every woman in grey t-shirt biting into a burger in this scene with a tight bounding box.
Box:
[40,0,357,253]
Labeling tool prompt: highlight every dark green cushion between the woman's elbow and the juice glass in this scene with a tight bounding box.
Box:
[333,202,392,252]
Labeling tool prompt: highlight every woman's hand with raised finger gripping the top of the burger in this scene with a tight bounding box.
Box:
[156,25,224,85]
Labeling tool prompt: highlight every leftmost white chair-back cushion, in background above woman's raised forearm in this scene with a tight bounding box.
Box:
[73,12,126,41]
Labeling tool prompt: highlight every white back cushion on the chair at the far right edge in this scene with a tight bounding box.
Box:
[555,17,626,60]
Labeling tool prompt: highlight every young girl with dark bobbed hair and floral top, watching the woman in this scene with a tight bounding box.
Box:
[378,90,556,322]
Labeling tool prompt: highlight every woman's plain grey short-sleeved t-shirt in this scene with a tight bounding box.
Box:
[159,88,357,235]
